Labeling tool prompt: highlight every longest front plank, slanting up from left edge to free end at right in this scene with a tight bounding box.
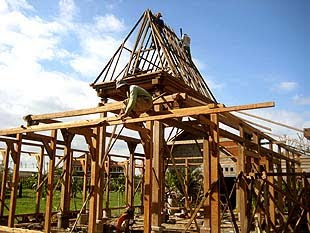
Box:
[0,102,274,136]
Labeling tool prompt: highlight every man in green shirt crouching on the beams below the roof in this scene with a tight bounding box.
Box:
[116,80,153,119]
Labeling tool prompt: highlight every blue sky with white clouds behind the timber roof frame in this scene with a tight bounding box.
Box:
[0,0,310,139]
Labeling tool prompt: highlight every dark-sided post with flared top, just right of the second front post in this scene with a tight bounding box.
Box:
[58,130,73,229]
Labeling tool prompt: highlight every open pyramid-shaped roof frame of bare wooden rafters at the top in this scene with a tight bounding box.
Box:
[91,10,216,102]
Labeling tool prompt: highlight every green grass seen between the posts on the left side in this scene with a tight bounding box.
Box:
[4,189,140,215]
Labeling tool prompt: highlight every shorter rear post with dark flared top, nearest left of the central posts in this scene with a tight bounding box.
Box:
[127,142,137,207]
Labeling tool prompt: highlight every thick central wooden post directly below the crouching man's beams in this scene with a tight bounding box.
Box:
[152,105,164,232]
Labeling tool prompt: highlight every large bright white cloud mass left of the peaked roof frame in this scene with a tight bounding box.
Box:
[0,0,124,128]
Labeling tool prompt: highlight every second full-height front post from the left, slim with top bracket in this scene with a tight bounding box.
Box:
[44,130,57,233]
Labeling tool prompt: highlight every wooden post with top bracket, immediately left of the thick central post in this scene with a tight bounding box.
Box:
[140,122,153,233]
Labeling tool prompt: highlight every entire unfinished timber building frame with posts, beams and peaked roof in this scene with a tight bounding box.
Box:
[0,10,310,233]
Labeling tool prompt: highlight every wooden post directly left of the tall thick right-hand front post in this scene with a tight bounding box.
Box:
[200,139,211,232]
